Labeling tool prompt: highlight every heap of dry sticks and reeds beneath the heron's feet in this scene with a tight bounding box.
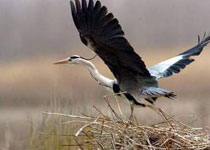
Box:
[29,99,210,150]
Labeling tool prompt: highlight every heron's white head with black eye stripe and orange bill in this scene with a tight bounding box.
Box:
[54,55,85,65]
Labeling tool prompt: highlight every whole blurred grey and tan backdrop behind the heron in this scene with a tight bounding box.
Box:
[0,0,210,147]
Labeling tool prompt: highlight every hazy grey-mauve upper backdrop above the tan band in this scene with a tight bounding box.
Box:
[0,0,210,63]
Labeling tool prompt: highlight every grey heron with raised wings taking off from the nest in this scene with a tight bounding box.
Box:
[55,0,210,116]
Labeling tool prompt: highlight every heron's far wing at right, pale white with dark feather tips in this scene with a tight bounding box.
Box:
[149,34,210,79]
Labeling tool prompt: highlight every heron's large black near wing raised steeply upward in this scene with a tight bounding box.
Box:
[70,0,151,81]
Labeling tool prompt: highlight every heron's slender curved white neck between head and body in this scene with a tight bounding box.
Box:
[80,59,114,88]
